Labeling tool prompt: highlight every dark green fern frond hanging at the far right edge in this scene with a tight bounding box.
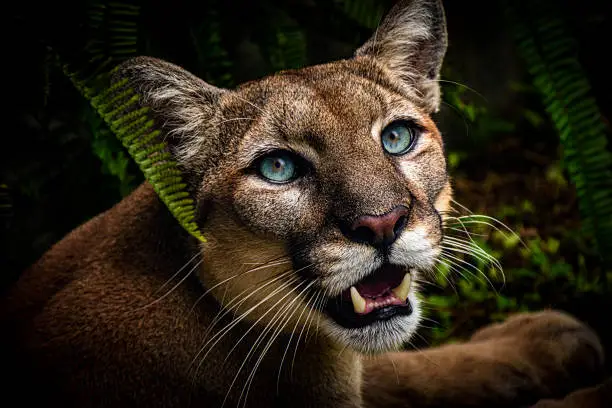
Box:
[507,0,612,266]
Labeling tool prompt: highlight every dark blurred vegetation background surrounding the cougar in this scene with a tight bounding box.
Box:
[0,0,612,364]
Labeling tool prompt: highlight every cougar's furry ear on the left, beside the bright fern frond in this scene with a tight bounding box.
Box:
[111,57,229,171]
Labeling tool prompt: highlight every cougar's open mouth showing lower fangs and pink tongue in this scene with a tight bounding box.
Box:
[327,264,412,328]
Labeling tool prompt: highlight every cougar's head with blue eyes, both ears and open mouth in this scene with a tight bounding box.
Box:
[119,1,451,352]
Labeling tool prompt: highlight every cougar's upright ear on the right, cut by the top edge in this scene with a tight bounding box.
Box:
[355,0,447,112]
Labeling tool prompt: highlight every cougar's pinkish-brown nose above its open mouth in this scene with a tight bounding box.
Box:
[349,205,409,247]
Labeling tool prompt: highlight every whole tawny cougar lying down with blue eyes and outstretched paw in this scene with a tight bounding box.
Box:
[1,0,603,408]
